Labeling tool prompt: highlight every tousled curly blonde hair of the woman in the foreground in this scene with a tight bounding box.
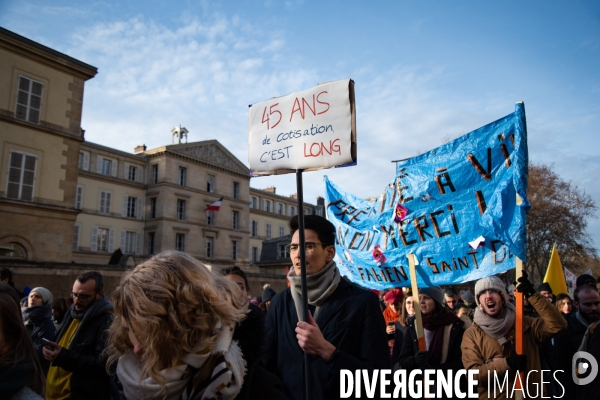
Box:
[106,251,248,386]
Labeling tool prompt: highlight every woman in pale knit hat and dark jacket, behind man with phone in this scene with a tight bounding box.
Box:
[21,287,56,375]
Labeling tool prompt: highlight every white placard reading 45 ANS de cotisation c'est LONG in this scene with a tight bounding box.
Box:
[248,79,356,176]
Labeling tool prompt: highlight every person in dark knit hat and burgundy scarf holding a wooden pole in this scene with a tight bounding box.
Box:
[395,286,464,384]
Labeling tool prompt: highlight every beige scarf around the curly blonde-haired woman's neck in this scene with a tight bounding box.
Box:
[117,322,246,400]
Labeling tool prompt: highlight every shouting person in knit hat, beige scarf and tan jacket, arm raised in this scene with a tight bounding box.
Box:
[461,271,567,399]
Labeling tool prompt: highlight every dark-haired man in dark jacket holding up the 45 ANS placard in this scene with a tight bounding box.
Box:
[265,215,391,400]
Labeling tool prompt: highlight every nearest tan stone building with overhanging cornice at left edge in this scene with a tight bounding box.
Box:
[0,28,97,262]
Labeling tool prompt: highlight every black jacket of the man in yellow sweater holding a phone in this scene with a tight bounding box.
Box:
[52,297,113,400]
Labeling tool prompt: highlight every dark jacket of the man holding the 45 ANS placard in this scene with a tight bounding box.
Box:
[265,278,391,400]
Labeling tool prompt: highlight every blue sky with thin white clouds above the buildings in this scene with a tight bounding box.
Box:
[0,0,600,249]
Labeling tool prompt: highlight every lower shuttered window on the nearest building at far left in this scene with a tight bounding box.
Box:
[6,151,37,201]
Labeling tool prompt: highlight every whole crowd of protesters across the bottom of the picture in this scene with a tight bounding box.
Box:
[0,215,600,400]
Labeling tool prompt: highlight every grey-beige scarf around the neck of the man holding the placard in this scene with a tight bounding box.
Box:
[288,261,341,321]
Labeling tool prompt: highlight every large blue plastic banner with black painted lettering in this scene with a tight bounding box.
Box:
[325,103,529,289]
